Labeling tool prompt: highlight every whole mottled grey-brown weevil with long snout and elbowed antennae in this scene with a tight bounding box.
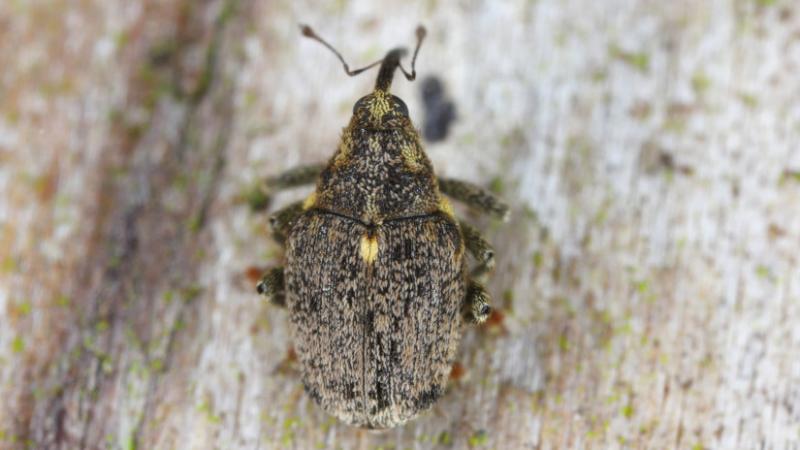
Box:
[254,25,508,428]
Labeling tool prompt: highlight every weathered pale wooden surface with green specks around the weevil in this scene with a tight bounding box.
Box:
[0,0,800,449]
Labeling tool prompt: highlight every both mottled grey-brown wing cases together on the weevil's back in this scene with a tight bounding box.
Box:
[286,210,465,428]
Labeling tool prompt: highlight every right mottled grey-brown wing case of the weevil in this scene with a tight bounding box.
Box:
[366,217,464,427]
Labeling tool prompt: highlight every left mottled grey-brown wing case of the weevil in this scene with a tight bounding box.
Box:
[285,214,364,420]
